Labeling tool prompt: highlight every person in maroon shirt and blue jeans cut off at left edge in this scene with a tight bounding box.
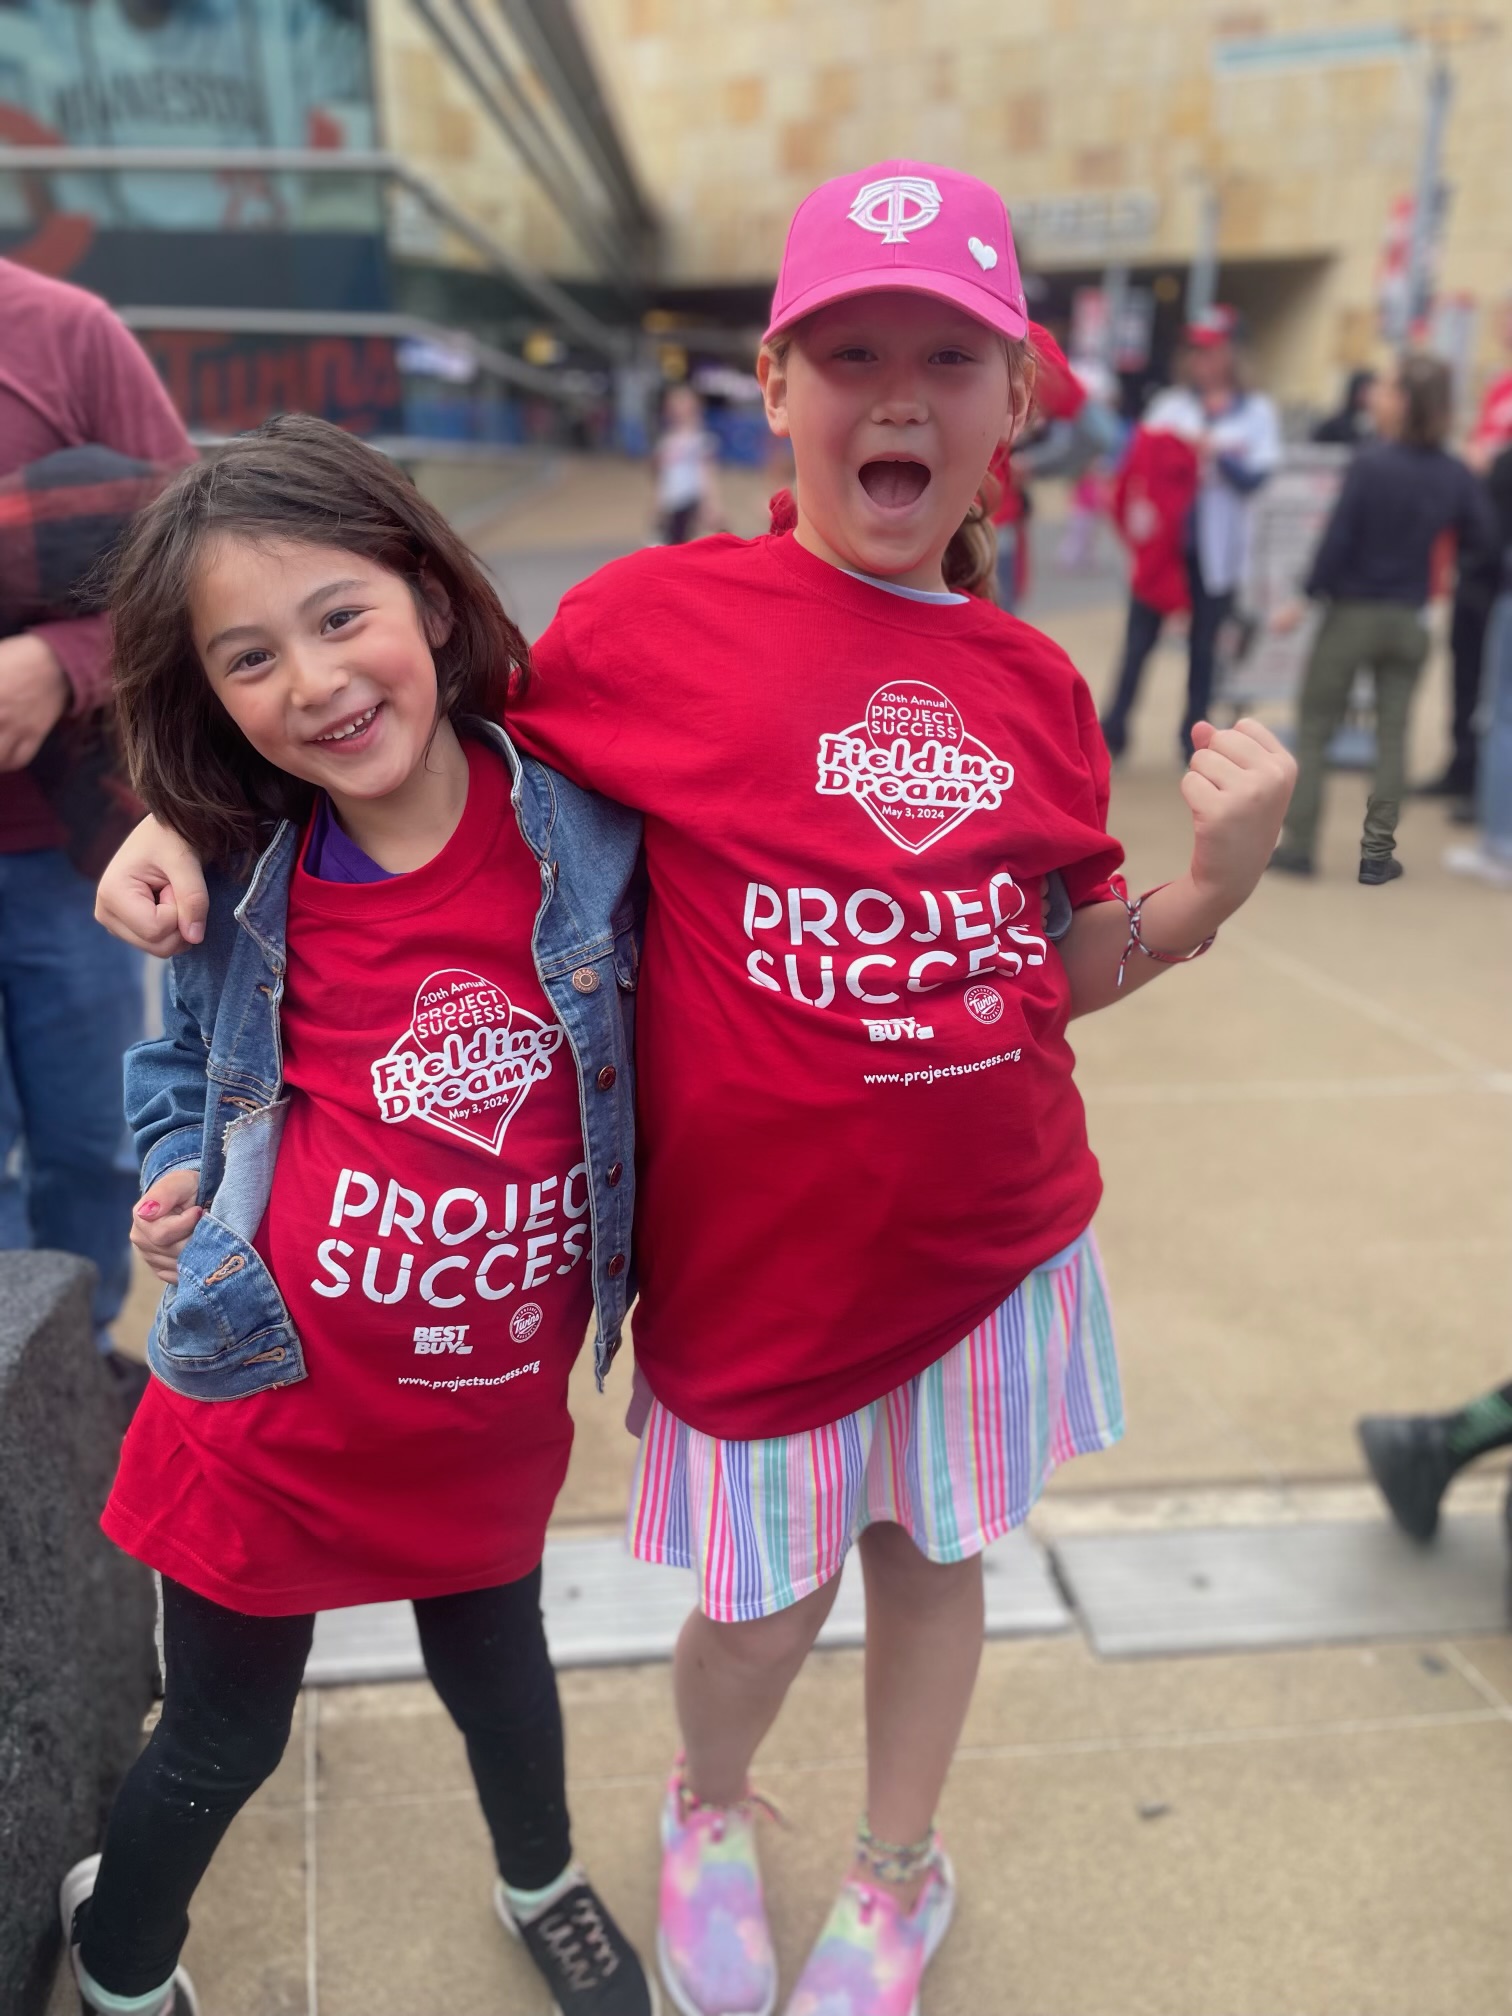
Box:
[0,258,194,1403]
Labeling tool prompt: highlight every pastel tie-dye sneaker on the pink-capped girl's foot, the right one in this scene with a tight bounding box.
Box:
[788,1847,956,2016]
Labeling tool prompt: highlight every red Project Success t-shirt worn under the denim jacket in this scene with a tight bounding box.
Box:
[105,744,593,1617]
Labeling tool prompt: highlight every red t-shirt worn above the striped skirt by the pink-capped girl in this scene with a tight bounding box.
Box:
[512,536,1121,1437]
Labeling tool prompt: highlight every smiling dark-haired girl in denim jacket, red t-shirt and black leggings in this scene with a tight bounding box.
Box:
[62,417,655,2016]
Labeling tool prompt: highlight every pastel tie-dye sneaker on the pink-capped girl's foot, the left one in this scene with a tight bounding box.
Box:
[657,1758,776,2016]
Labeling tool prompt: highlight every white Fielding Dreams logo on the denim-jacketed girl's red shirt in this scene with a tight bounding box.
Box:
[373,968,564,1155]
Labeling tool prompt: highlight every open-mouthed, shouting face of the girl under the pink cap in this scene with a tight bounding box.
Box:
[758,292,1030,589]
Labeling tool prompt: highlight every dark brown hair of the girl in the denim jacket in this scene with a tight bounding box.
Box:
[109,413,530,865]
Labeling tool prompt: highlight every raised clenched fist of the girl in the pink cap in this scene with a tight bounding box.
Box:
[1181,720,1296,925]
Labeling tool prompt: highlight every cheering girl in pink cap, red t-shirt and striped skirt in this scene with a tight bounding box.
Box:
[103,161,1294,2016]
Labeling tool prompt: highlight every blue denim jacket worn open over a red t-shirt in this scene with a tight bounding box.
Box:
[125,722,643,1399]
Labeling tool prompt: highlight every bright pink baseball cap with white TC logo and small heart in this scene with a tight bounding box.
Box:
[764,161,1028,343]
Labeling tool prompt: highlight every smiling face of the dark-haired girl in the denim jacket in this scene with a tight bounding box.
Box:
[190,536,448,808]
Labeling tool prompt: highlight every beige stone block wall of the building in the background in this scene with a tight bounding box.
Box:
[375,0,1512,397]
